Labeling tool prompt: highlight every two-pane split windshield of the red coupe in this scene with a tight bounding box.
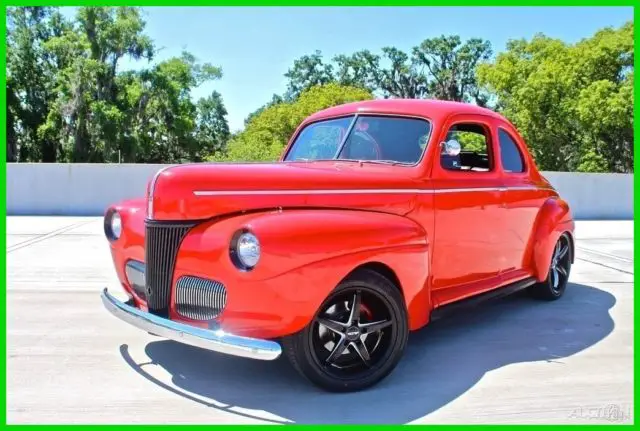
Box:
[285,115,431,165]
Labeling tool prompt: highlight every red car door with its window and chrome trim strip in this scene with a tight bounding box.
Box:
[431,115,505,306]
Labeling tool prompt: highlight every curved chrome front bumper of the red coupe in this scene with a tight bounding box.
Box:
[101,288,282,361]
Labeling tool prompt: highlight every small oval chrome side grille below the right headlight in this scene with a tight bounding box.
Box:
[176,276,227,320]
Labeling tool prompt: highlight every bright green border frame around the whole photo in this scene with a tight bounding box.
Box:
[0,0,640,430]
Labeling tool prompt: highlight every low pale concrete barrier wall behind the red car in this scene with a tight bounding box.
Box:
[7,163,633,219]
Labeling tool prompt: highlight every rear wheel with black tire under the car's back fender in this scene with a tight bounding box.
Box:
[528,233,572,301]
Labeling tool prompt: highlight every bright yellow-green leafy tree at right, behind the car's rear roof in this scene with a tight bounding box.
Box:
[478,23,633,172]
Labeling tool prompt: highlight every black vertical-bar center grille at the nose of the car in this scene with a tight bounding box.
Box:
[145,220,194,317]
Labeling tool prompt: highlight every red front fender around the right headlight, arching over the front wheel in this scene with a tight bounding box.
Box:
[174,209,430,338]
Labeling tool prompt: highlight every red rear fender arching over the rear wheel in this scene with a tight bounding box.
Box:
[529,196,575,282]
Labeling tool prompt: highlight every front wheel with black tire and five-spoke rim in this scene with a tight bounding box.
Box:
[282,270,409,392]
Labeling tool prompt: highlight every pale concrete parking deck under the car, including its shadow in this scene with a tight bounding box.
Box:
[7,217,634,424]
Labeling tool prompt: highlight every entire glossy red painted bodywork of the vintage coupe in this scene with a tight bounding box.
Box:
[105,100,574,338]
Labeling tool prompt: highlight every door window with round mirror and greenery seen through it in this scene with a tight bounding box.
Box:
[440,123,493,172]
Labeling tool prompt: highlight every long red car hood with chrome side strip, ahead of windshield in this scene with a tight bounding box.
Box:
[147,161,419,221]
